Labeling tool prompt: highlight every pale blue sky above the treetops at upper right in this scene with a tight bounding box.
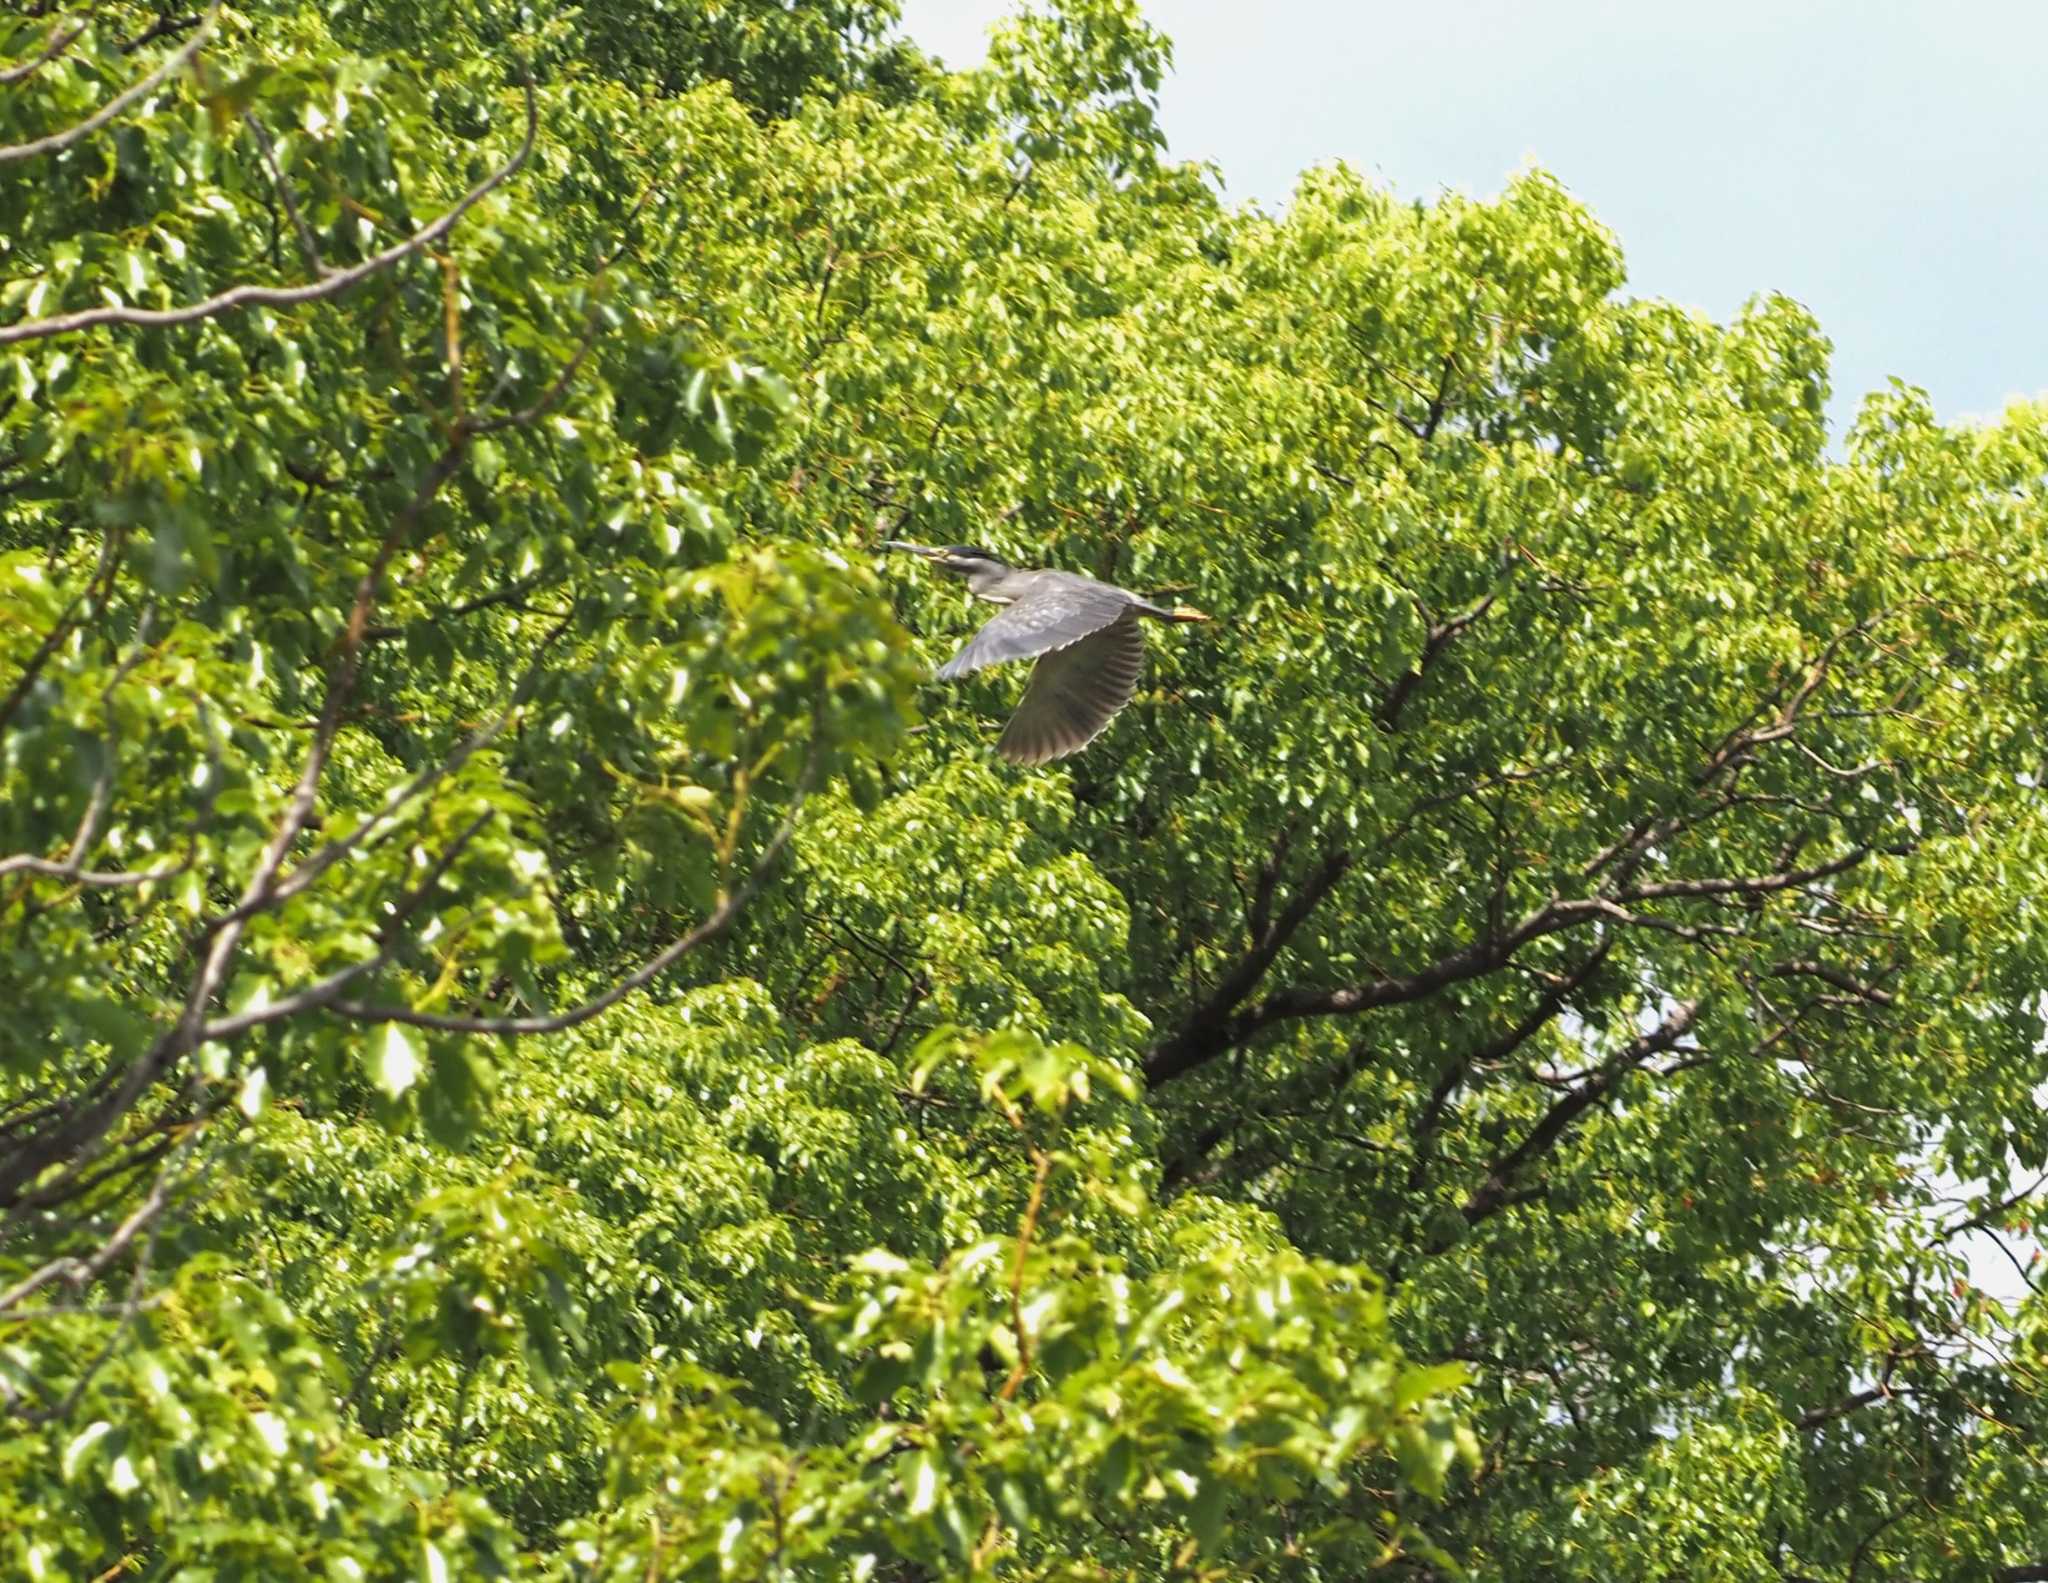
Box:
[903,0,2048,434]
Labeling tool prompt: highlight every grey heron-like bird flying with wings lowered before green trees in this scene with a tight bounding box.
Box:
[883,539,1208,764]
